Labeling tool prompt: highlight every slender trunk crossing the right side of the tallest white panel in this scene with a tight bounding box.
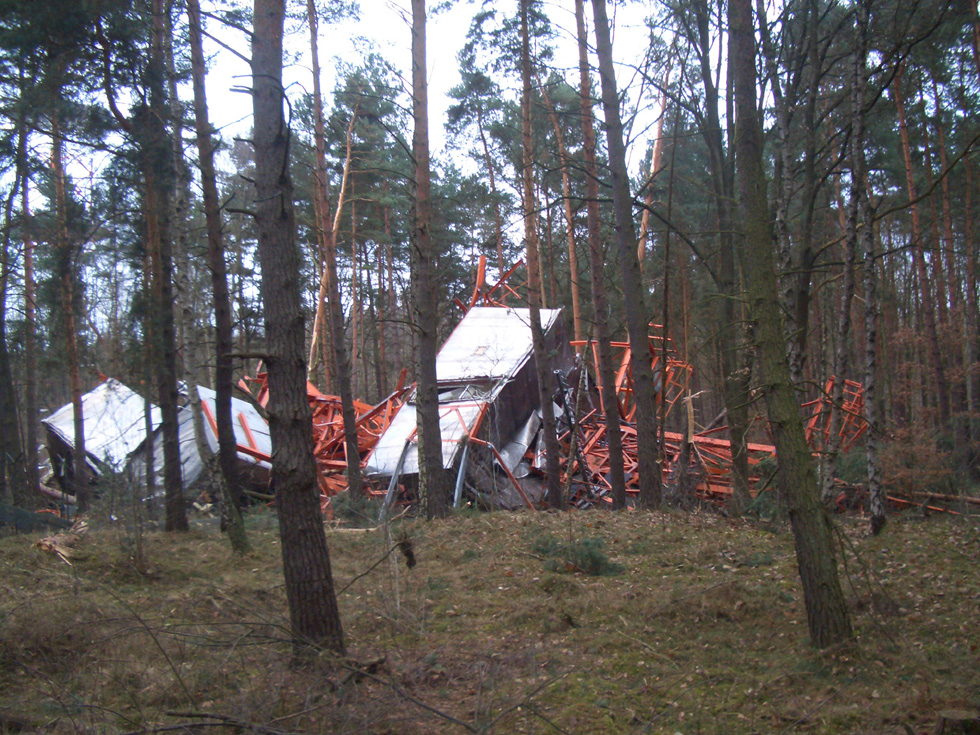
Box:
[521,0,563,508]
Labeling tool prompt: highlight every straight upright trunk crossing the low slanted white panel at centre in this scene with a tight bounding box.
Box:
[412,0,449,519]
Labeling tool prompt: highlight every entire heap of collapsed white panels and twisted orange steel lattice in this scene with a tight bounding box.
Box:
[44,262,867,515]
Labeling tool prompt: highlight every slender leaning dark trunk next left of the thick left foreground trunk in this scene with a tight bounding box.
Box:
[187,0,249,554]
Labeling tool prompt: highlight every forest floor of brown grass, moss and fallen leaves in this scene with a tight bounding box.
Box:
[0,509,980,735]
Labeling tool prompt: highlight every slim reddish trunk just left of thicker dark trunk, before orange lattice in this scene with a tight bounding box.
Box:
[575,0,626,510]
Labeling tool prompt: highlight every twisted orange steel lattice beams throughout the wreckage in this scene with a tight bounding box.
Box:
[241,256,867,514]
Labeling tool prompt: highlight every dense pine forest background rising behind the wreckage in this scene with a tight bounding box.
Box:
[0,0,980,506]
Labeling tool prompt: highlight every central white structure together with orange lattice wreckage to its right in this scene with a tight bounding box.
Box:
[363,261,867,508]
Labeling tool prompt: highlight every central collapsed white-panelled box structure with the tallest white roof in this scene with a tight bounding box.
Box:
[365,307,571,508]
